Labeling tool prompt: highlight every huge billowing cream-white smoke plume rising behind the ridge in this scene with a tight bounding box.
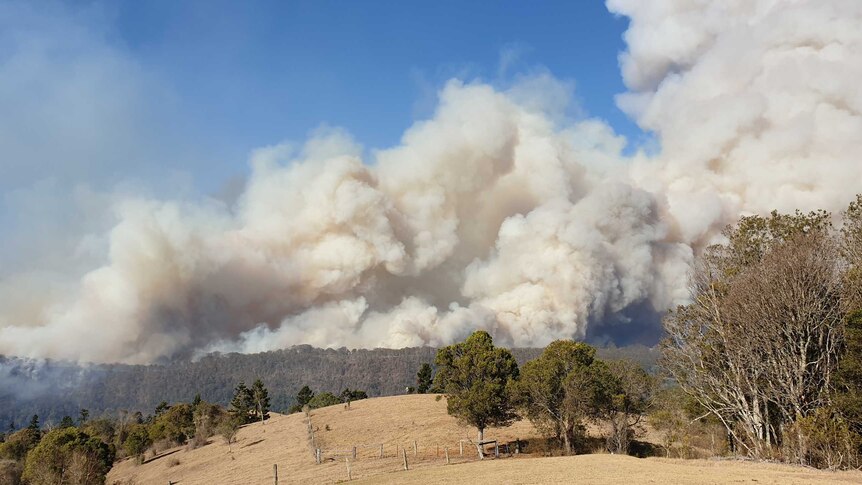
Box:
[0,0,862,362]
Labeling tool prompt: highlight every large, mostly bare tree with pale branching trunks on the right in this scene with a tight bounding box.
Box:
[661,212,842,457]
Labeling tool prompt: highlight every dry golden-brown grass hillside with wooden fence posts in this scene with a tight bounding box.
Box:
[107,395,862,485]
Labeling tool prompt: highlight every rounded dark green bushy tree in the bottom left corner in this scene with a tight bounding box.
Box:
[23,428,114,485]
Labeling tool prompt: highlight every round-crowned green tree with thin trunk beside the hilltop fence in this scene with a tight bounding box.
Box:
[435,330,518,457]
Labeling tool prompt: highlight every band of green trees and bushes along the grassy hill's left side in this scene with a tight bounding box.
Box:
[0,379,270,485]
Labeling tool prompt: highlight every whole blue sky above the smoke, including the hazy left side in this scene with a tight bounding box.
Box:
[0,0,643,214]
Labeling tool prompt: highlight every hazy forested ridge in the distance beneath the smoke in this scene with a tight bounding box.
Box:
[0,345,658,431]
